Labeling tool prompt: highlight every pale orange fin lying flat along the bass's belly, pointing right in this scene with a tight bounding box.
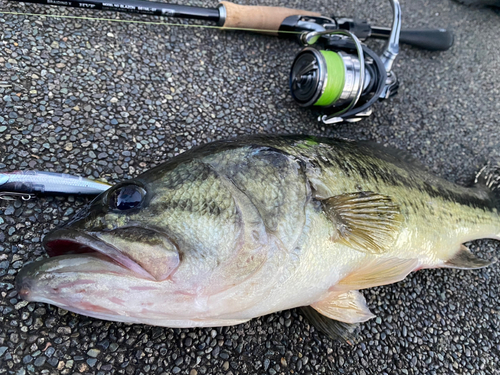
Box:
[334,257,420,291]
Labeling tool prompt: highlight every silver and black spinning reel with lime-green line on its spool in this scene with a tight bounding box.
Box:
[288,0,401,124]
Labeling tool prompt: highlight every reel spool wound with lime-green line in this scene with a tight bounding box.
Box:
[290,47,371,107]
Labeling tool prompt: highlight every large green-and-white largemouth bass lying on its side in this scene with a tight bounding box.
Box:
[16,136,500,335]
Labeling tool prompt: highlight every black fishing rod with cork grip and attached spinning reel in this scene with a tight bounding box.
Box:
[11,0,453,124]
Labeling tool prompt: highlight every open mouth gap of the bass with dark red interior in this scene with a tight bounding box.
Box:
[43,229,156,281]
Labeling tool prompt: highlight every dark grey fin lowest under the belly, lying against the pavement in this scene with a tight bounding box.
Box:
[300,306,358,344]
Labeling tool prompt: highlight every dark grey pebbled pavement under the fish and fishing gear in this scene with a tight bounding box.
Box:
[0,0,500,375]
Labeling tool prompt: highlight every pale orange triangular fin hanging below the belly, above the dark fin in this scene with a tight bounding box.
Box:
[311,290,375,324]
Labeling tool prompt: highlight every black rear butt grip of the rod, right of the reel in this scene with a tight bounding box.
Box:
[370,26,453,51]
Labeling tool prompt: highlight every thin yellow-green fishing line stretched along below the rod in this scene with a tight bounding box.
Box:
[0,10,302,34]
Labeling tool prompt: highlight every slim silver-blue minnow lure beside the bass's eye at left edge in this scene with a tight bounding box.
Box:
[0,170,111,200]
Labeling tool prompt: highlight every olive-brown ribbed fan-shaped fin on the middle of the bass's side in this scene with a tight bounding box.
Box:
[322,191,403,254]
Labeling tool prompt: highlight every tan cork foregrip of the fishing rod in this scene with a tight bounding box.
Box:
[218,1,321,34]
